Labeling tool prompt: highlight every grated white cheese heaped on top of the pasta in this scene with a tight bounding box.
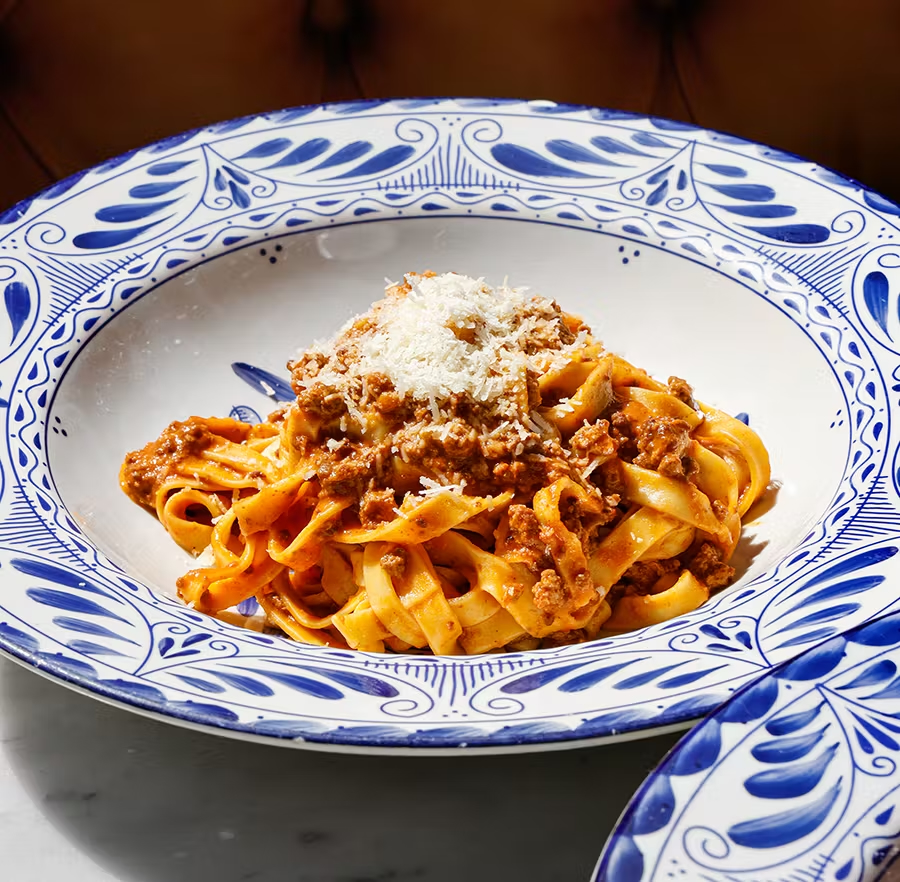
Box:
[299,273,585,416]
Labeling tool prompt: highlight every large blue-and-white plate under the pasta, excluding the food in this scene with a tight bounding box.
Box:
[0,99,900,751]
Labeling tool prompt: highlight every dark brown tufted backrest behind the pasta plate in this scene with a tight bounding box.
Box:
[0,0,900,210]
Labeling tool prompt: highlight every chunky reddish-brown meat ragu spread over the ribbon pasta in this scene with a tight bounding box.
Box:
[121,273,767,648]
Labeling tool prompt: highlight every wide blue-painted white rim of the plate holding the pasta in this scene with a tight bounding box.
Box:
[0,98,900,753]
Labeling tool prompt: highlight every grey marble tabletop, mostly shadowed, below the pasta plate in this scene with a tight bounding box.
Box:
[0,658,678,882]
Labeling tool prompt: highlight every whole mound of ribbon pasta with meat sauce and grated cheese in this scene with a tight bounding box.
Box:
[120,272,769,654]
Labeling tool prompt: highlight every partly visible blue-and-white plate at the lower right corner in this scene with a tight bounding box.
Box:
[594,612,900,882]
